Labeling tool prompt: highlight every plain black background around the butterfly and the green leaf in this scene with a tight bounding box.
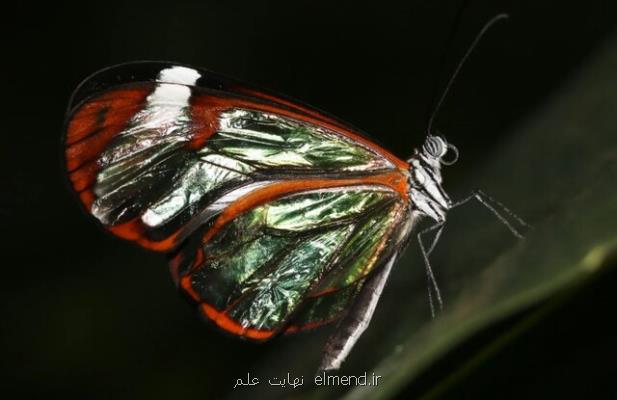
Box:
[0,0,617,398]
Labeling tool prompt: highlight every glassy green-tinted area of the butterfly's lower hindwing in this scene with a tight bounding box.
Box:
[178,186,410,338]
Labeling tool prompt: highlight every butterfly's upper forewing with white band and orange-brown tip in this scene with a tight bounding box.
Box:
[65,63,401,251]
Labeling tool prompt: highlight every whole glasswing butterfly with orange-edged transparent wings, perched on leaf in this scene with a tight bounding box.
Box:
[64,13,524,369]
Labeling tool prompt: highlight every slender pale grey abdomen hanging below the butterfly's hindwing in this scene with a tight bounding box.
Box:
[319,254,397,371]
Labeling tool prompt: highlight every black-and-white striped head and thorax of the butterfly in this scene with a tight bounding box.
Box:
[408,135,458,222]
